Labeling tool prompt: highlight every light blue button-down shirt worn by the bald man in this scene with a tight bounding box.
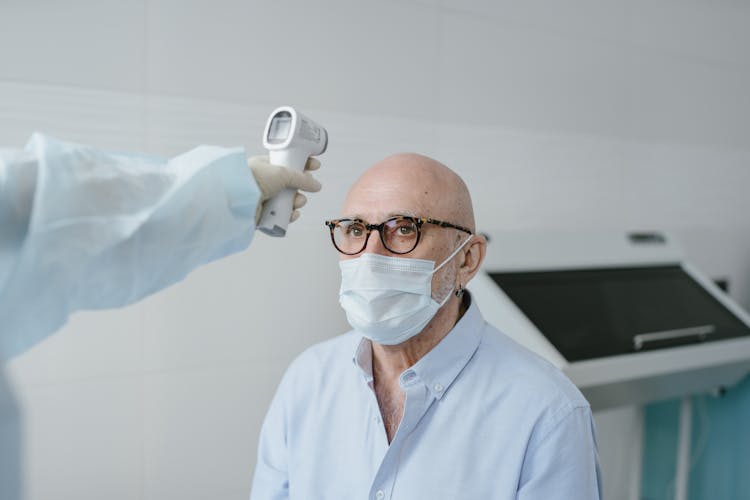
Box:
[251,299,601,500]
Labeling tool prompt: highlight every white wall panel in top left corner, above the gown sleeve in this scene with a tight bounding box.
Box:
[0,0,146,91]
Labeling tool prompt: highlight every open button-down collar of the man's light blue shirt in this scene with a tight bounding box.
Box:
[352,294,484,399]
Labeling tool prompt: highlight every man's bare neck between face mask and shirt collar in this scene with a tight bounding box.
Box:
[372,297,465,384]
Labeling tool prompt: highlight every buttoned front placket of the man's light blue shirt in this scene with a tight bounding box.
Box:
[368,370,434,500]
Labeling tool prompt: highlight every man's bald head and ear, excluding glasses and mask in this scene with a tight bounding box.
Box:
[334,153,486,322]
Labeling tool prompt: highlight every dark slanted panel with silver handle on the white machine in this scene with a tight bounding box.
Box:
[490,265,750,362]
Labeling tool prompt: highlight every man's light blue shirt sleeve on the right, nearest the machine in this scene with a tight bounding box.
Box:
[516,406,601,500]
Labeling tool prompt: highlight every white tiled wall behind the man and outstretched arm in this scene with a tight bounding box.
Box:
[0,0,750,500]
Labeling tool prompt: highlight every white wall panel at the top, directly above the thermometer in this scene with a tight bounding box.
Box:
[148,0,440,117]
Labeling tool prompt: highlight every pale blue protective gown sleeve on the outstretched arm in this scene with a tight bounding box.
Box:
[0,134,260,357]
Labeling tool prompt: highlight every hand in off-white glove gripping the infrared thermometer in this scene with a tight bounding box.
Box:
[247,156,321,224]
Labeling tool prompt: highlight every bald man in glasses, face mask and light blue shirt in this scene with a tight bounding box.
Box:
[251,154,601,500]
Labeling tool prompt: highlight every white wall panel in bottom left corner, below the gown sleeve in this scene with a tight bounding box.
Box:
[20,376,143,500]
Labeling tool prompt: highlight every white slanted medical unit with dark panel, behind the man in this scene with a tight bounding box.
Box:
[469,232,750,410]
